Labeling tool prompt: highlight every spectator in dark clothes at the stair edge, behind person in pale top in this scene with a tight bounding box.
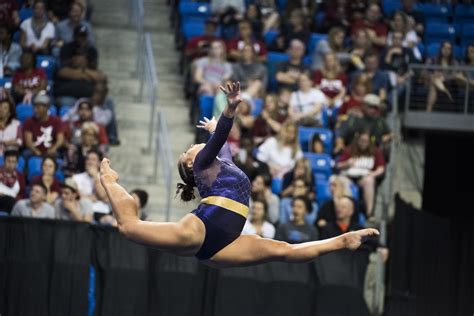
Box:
[185,18,219,62]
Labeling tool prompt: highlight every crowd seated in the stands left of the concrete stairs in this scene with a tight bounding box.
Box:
[0,0,148,225]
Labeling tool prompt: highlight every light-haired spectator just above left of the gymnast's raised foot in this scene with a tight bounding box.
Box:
[65,122,103,176]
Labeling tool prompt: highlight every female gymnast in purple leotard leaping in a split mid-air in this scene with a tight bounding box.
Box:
[100,82,379,268]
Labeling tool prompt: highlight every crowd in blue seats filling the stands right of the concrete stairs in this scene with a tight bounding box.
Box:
[176,0,474,247]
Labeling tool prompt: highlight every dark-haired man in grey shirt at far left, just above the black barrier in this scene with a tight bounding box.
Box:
[12,183,55,219]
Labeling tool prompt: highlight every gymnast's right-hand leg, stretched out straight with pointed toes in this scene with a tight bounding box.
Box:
[206,228,378,268]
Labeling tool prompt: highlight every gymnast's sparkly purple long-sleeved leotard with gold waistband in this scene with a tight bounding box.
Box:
[191,115,254,260]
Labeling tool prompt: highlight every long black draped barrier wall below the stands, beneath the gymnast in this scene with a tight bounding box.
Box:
[0,218,368,316]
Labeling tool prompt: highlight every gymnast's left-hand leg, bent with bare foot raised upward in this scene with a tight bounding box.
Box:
[100,158,206,256]
